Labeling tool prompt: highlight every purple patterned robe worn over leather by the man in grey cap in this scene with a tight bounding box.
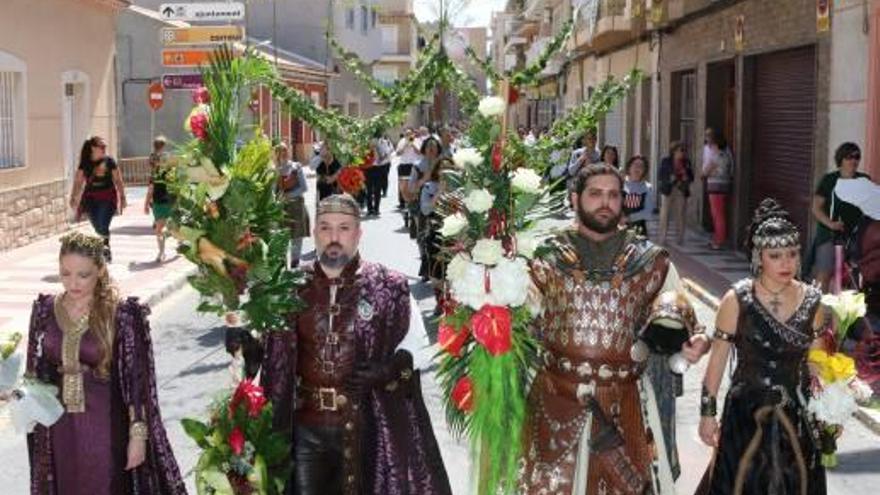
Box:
[262,258,452,495]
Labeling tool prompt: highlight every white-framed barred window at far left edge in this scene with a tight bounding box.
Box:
[0,69,25,169]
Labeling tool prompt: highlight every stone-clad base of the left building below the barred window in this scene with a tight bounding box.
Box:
[0,180,68,251]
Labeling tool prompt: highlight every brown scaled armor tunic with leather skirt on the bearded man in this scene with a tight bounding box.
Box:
[521,232,674,495]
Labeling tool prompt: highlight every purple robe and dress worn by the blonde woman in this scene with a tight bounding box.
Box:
[27,295,186,495]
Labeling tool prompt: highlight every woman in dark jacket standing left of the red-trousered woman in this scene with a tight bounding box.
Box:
[658,141,694,245]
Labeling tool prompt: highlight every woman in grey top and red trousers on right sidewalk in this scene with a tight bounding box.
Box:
[700,129,733,251]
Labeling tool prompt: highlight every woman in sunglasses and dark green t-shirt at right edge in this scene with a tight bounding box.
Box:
[812,142,868,291]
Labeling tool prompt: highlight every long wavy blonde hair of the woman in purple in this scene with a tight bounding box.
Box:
[59,232,119,377]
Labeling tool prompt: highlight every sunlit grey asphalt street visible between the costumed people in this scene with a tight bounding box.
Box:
[0,170,880,495]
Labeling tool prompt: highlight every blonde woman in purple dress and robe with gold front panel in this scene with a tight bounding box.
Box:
[27,233,186,495]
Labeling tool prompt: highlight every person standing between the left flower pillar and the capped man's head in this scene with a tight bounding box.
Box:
[275,143,311,268]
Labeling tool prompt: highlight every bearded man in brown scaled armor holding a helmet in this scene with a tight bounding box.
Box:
[521,164,708,495]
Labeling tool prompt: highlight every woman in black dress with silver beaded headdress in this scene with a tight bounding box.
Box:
[698,199,826,495]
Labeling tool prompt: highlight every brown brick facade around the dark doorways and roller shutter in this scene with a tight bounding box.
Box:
[659,0,833,244]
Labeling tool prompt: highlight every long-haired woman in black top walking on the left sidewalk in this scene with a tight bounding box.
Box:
[70,136,127,263]
